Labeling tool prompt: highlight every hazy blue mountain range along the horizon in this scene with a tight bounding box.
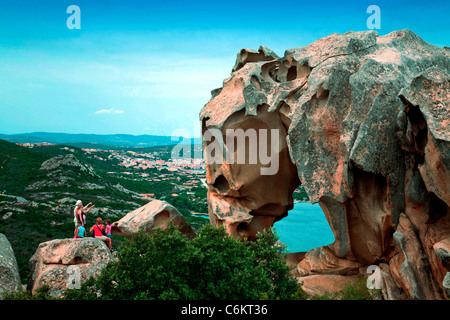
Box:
[0,132,201,148]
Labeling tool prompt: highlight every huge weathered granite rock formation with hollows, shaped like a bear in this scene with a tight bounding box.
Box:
[200,30,450,299]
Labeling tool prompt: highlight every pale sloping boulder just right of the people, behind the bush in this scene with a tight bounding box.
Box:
[112,200,195,239]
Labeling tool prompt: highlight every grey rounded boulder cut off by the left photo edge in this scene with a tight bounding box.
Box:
[0,233,21,300]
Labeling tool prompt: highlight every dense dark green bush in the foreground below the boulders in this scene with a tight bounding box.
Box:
[65,225,298,300]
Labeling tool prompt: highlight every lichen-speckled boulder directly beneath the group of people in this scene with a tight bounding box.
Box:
[27,238,113,297]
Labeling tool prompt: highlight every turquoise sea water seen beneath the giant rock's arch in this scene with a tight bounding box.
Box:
[274,202,334,252]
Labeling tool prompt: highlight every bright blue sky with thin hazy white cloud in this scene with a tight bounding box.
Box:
[0,0,450,136]
